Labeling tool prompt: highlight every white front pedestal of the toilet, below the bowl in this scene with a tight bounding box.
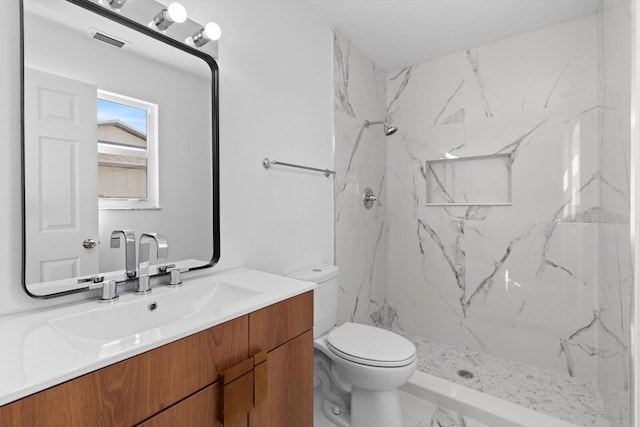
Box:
[351,387,403,427]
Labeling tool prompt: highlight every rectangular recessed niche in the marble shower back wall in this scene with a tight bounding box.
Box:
[426,153,513,206]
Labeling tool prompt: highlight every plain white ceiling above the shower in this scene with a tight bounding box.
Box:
[303,0,599,71]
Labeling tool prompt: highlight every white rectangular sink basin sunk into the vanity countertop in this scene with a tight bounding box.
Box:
[49,282,259,341]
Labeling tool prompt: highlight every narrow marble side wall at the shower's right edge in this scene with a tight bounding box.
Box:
[596,0,633,425]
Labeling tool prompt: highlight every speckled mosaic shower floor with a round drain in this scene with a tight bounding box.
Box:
[403,334,625,427]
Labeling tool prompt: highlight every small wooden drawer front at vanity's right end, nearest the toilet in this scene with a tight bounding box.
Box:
[249,291,313,354]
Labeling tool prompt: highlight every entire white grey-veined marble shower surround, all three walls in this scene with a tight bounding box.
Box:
[334,4,632,425]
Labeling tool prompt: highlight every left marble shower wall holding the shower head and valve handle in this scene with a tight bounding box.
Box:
[333,32,394,327]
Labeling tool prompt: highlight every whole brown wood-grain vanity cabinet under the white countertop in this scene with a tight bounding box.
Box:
[0,292,313,427]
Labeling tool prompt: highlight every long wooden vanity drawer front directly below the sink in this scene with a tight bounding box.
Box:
[0,316,248,427]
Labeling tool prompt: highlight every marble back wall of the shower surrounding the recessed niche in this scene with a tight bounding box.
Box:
[387,13,630,402]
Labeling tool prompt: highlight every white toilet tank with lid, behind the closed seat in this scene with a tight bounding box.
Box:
[289,264,338,338]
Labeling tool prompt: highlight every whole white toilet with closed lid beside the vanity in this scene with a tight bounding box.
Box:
[290,264,416,427]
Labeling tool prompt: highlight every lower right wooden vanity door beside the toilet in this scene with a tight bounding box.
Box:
[249,330,313,427]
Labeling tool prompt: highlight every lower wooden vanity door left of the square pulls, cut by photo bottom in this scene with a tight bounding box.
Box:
[139,382,247,427]
